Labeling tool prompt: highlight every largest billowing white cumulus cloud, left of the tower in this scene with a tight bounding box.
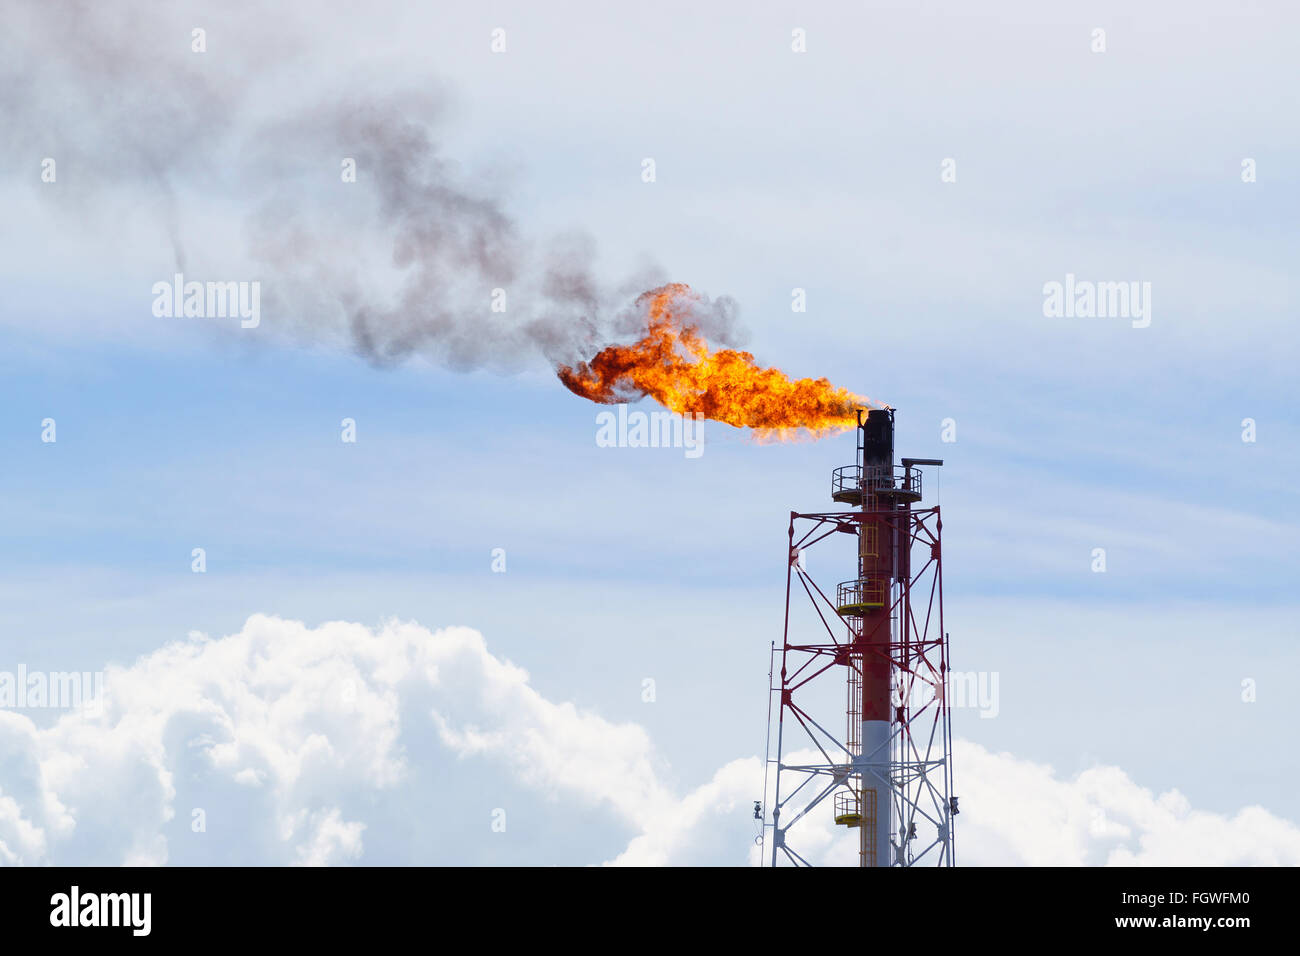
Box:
[0,615,728,864]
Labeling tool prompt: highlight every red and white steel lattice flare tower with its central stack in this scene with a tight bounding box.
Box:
[763,408,957,866]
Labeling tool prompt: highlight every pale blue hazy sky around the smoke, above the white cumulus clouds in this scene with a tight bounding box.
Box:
[0,4,1300,862]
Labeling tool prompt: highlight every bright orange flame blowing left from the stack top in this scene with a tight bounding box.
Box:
[558,282,871,440]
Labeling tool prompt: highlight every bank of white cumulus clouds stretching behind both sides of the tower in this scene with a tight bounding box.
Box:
[0,615,1300,865]
